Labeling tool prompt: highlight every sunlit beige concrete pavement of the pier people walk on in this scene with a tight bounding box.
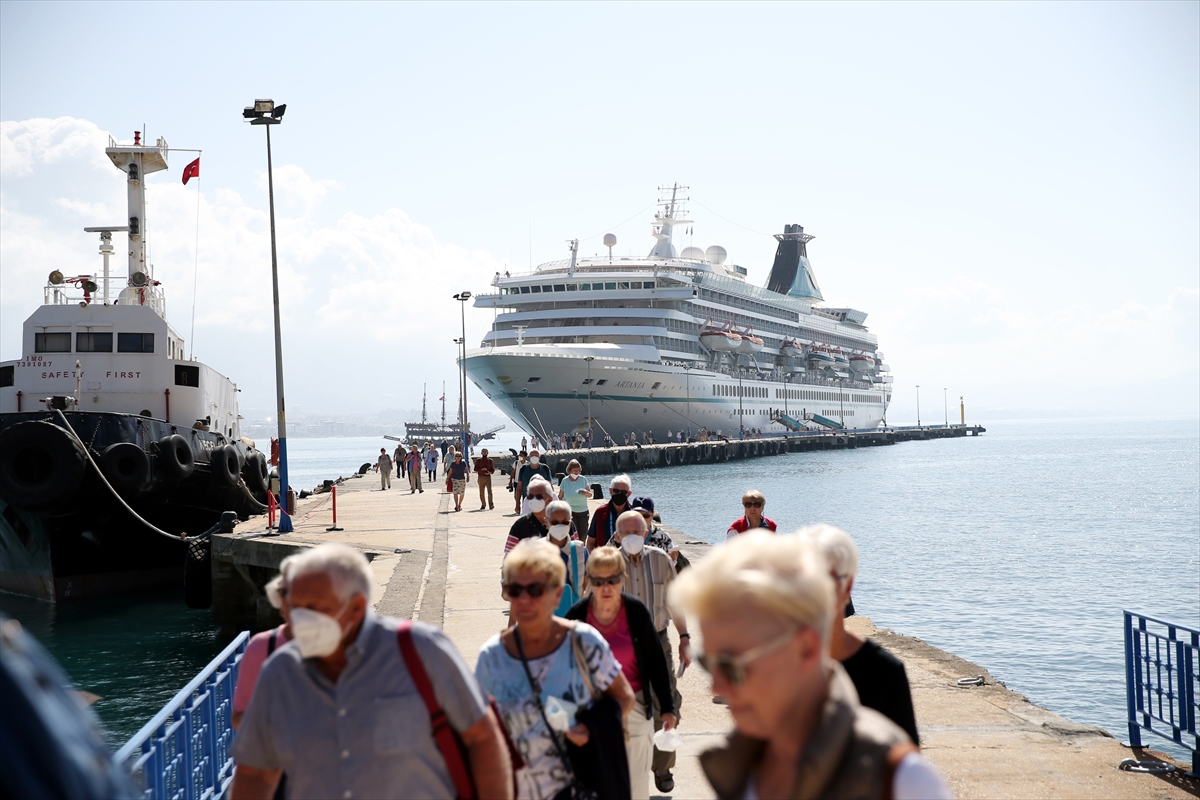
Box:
[214,474,1200,799]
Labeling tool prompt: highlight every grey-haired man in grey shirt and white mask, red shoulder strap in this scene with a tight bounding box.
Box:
[232,543,512,800]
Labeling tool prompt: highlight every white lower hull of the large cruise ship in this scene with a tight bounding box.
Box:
[467,345,887,441]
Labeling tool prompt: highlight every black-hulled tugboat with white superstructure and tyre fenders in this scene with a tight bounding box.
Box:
[0,133,269,603]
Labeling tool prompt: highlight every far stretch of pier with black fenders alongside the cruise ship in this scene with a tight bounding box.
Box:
[492,425,986,475]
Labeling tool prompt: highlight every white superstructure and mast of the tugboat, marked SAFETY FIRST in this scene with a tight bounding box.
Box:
[0,134,240,440]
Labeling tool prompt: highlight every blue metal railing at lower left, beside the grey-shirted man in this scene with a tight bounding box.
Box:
[114,631,250,800]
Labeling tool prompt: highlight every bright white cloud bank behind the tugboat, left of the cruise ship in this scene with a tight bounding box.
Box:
[0,120,499,411]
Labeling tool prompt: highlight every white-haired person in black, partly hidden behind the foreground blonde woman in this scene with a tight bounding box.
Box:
[798,525,920,746]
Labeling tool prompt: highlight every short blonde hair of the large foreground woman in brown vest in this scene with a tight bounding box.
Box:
[668,530,834,645]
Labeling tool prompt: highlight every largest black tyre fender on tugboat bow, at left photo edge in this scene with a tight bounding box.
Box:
[0,420,88,510]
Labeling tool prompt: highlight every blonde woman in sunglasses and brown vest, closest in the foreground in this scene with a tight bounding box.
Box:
[671,531,950,800]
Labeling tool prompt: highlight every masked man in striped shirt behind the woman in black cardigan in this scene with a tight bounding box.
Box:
[612,511,691,793]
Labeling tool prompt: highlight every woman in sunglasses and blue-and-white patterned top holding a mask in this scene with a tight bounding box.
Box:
[475,540,635,800]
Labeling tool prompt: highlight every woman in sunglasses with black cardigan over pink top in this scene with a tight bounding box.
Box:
[566,547,677,800]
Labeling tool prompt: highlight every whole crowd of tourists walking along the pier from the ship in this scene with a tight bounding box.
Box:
[232,462,950,800]
